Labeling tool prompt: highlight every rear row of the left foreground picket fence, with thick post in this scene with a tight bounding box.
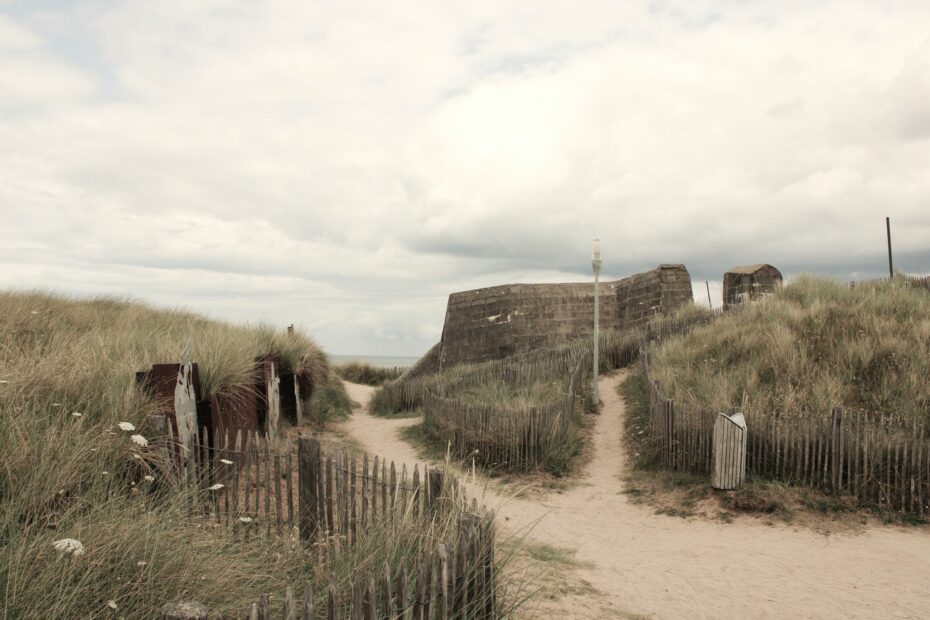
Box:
[155,429,468,544]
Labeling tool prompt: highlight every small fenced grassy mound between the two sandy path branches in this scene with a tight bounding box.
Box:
[369,344,590,475]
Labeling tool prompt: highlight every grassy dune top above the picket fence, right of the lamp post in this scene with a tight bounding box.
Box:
[650,277,930,425]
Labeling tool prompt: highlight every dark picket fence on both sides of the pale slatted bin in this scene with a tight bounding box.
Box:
[643,356,930,516]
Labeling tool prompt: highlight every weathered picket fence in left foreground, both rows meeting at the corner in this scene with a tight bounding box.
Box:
[153,431,497,618]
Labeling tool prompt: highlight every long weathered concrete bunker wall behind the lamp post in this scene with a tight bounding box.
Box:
[439,265,692,368]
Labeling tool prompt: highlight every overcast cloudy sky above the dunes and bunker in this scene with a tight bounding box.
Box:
[0,0,930,355]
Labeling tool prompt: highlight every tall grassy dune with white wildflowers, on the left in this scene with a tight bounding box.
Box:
[0,293,348,618]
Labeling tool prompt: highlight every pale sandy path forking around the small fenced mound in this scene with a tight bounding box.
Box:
[347,375,930,618]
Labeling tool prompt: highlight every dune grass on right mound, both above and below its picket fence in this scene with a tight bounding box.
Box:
[622,276,930,523]
